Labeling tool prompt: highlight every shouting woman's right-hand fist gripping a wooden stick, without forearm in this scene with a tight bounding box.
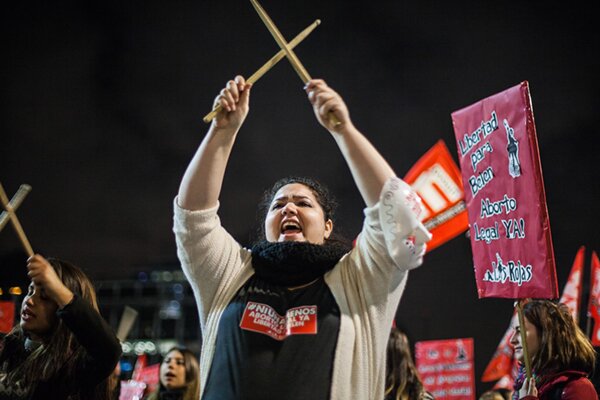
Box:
[305,79,351,132]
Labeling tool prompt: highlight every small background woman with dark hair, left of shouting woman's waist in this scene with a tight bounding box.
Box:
[147,347,200,400]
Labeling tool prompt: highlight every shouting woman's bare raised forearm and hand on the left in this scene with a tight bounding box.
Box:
[177,75,252,210]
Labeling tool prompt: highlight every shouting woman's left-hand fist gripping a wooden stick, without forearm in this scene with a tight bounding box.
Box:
[213,75,252,130]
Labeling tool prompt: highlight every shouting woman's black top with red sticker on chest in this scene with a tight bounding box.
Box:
[202,276,340,400]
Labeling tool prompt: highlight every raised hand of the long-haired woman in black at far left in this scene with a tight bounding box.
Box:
[27,254,73,307]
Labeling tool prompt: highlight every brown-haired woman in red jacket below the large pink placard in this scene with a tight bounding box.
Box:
[511,300,598,400]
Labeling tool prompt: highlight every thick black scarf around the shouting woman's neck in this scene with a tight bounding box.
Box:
[252,241,351,287]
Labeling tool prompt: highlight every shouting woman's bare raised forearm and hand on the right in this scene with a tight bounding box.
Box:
[306,79,395,207]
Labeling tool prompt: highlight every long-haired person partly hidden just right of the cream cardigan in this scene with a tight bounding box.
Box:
[385,328,434,400]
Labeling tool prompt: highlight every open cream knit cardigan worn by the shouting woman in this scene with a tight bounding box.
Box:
[173,178,430,400]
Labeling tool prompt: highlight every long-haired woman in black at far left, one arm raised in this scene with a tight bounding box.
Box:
[0,254,121,400]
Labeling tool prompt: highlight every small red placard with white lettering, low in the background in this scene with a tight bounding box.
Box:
[415,338,475,400]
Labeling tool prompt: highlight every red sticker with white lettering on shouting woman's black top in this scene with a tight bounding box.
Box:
[240,301,317,340]
